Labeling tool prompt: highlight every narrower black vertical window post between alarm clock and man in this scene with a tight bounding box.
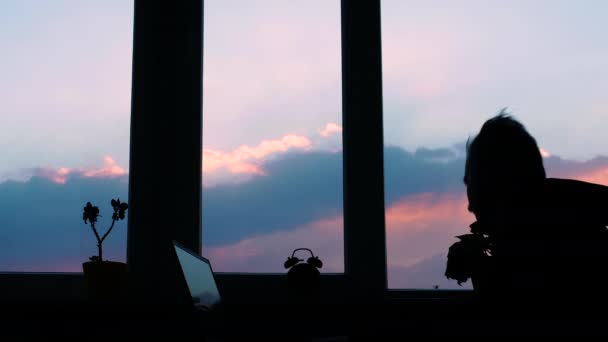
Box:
[342,0,387,298]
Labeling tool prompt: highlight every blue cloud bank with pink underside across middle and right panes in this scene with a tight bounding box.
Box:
[203,140,472,280]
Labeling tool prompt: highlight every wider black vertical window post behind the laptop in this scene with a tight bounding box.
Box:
[127,0,203,303]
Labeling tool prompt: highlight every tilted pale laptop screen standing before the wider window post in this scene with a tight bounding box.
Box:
[174,245,220,308]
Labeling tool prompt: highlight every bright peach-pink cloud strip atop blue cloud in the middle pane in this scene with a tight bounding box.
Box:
[203,134,312,175]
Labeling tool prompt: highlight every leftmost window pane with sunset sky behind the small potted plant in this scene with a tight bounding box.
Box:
[0,0,133,272]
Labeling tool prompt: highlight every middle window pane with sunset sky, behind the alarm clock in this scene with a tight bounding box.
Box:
[203,0,344,272]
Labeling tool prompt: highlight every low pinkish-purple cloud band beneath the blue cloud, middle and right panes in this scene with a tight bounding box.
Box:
[204,193,474,272]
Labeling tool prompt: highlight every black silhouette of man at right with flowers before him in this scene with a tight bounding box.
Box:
[446,110,608,320]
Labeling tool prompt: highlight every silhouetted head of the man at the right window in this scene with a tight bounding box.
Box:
[464,110,546,221]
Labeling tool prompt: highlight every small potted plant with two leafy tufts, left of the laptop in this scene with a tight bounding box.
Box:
[82,199,129,300]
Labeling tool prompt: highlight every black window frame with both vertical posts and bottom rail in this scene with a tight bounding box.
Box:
[0,0,471,302]
